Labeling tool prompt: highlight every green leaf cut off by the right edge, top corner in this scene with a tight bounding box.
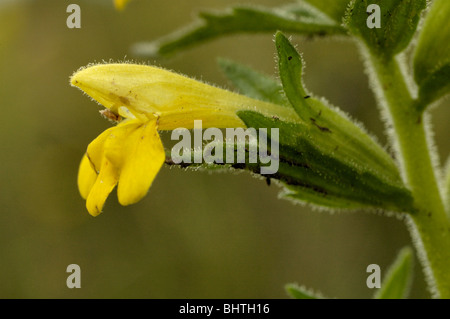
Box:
[414,0,450,108]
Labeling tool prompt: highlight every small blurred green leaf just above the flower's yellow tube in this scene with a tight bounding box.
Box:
[219,59,291,107]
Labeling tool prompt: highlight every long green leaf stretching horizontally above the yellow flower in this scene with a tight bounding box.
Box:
[132,3,346,56]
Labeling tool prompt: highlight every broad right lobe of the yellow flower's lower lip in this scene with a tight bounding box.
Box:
[117,120,165,205]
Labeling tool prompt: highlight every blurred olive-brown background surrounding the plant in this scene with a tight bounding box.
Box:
[0,0,450,298]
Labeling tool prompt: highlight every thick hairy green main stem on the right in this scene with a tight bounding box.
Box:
[370,55,450,298]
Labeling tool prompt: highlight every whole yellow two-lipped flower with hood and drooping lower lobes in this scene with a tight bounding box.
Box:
[71,64,297,216]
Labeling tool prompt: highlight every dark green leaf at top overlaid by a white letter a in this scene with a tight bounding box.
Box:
[346,0,426,59]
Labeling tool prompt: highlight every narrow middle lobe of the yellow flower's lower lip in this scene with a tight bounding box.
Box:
[86,158,118,216]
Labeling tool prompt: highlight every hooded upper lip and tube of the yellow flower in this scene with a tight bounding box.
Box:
[71,64,297,130]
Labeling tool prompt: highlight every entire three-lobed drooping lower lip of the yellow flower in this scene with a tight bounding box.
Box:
[83,119,165,216]
